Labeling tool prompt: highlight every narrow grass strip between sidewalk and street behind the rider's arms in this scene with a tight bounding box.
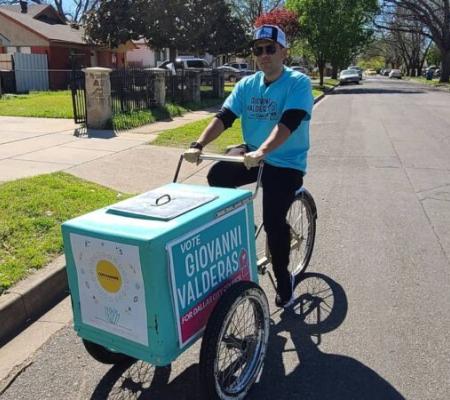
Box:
[151,88,323,153]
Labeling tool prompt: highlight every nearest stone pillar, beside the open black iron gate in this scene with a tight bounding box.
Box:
[83,67,112,129]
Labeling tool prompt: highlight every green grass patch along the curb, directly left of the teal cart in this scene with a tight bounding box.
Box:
[0,172,128,294]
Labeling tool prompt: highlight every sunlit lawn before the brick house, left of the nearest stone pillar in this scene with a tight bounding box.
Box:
[0,90,73,118]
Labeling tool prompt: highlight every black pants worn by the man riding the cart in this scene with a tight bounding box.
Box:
[208,146,303,294]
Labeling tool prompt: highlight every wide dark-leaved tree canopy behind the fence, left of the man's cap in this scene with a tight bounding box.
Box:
[86,0,246,61]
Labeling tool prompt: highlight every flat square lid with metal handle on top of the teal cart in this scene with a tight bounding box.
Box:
[107,186,218,221]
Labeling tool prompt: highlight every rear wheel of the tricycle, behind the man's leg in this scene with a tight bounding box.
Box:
[287,189,317,280]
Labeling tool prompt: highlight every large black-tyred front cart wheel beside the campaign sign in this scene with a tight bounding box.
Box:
[200,282,270,400]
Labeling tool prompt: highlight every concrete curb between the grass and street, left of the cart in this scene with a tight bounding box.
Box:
[0,255,68,346]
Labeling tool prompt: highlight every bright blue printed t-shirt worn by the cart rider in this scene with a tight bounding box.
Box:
[223,67,314,173]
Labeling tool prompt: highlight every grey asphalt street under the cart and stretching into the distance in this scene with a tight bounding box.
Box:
[0,78,450,400]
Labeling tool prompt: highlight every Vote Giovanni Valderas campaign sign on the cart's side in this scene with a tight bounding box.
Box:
[167,207,252,347]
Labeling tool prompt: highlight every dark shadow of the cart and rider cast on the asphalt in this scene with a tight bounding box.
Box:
[91,273,404,400]
